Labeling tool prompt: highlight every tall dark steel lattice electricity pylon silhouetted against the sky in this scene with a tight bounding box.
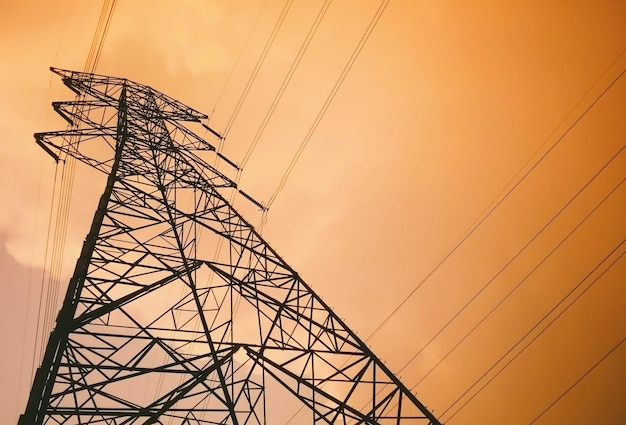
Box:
[19,69,439,425]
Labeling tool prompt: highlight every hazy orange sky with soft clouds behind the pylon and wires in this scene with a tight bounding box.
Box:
[0,0,626,425]
